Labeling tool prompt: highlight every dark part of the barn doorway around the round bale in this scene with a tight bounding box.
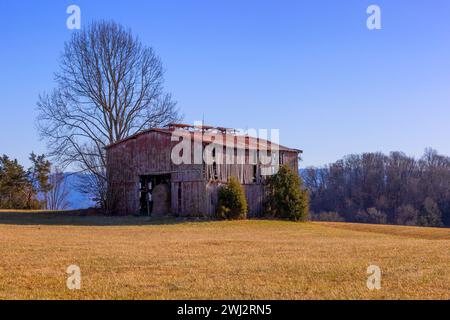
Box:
[139,174,170,216]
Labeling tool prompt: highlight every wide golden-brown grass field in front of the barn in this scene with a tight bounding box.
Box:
[0,212,450,299]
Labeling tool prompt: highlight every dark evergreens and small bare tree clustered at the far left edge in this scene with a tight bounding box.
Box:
[0,153,69,210]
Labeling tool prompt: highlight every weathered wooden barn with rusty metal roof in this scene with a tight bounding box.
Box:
[106,124,301,217]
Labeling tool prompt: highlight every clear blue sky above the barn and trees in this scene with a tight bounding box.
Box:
[0,0,450,166]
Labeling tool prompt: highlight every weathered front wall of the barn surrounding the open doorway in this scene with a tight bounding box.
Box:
[107,132,207,216]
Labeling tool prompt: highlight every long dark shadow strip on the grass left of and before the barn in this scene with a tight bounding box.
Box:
[0,212,213,226]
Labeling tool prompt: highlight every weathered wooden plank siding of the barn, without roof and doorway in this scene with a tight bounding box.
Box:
[106,131,298,217]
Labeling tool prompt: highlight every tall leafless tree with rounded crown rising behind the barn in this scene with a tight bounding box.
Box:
[38,22,180,207]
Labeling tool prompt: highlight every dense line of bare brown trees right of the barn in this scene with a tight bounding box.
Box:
[302,149,450,227]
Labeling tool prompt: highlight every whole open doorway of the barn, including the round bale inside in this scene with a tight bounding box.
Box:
[139,174,170,216]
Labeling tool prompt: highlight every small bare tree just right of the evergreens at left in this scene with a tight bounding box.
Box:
[46,168,70,210]
